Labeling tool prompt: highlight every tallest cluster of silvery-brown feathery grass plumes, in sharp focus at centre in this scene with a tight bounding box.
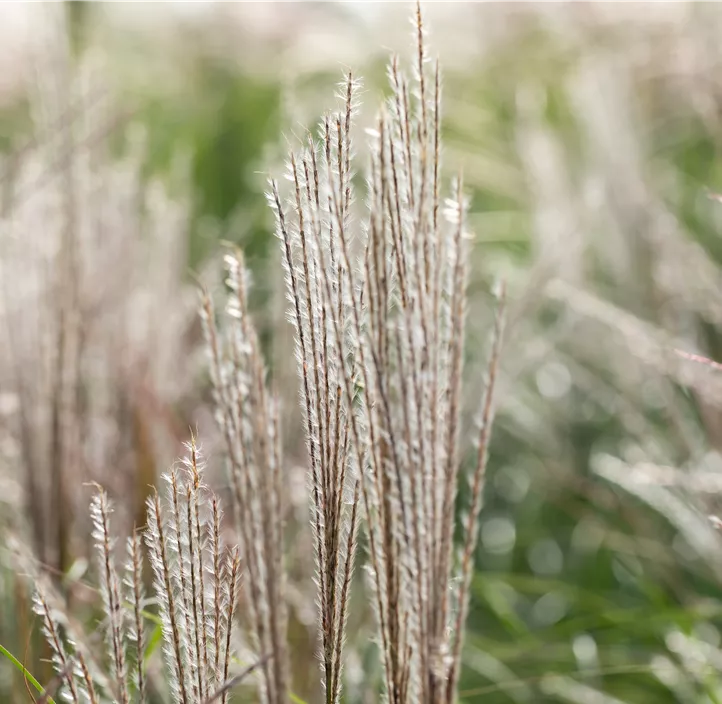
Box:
[268,2,502,704]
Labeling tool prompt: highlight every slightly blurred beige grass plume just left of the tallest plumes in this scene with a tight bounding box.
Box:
[201,253,289,704]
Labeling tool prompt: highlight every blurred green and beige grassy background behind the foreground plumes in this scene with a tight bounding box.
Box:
[7,0,722,704]
